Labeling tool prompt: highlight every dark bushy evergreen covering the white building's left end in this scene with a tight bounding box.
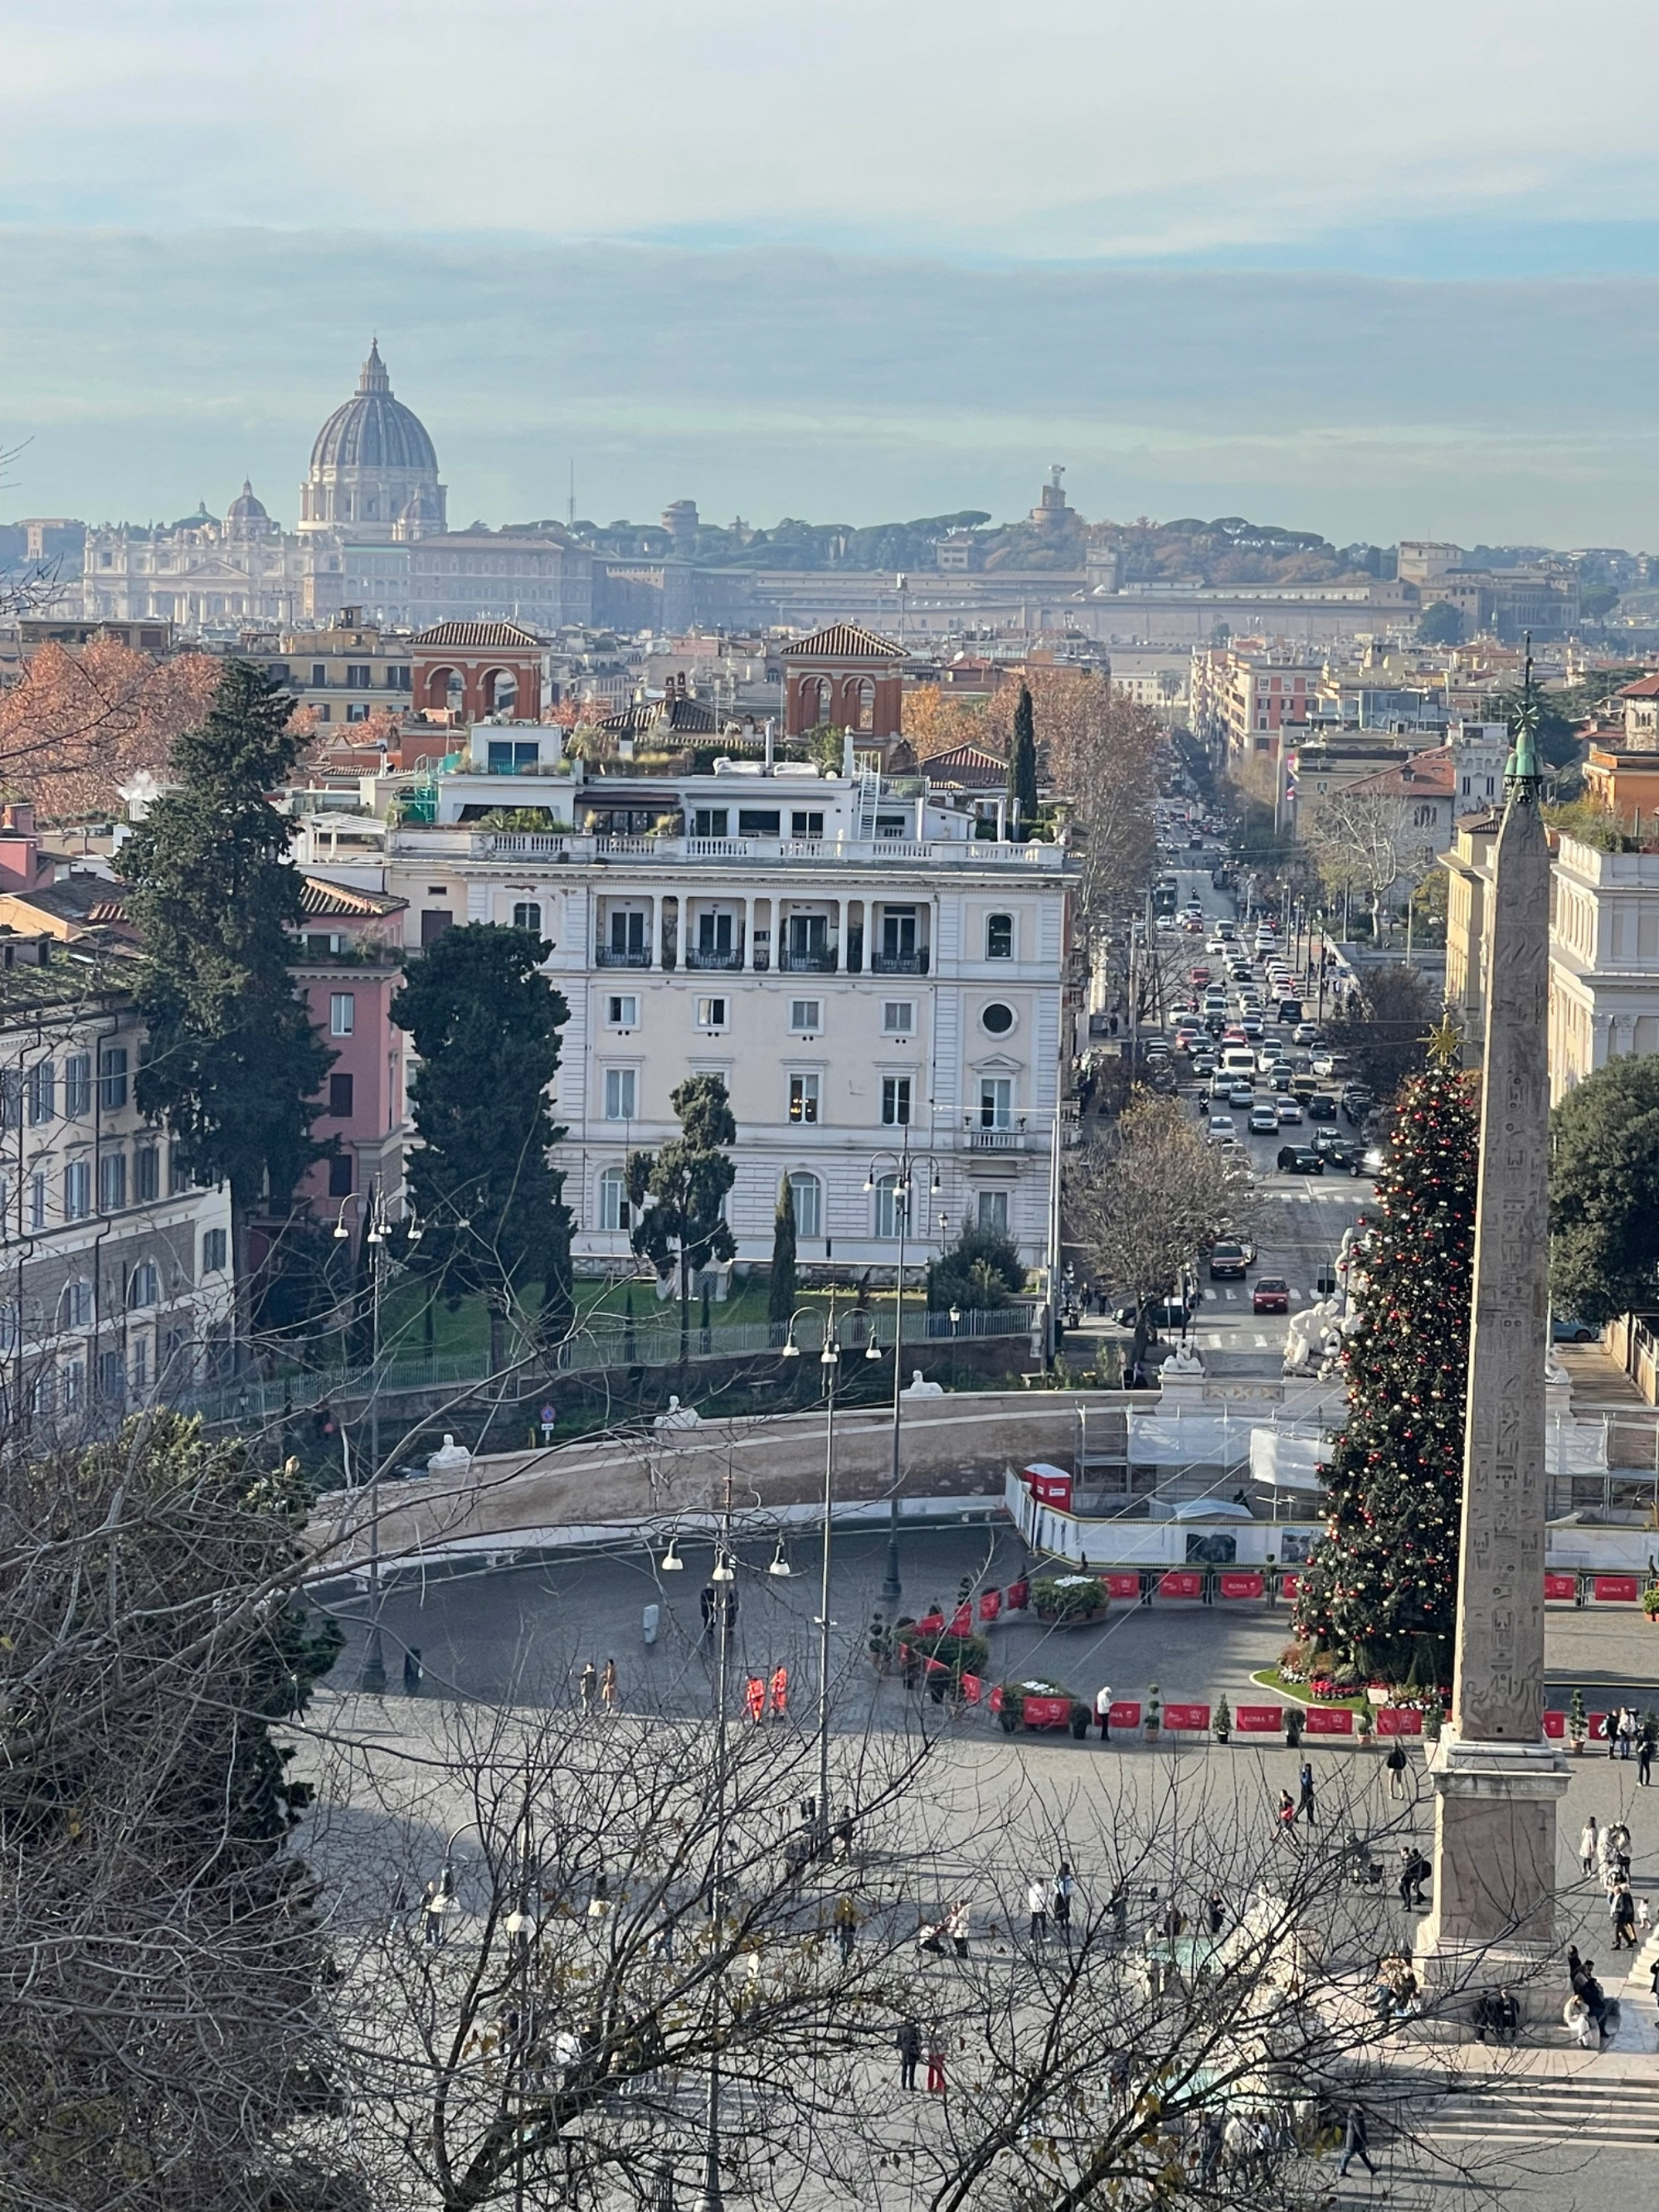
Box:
[392,923,571,1369]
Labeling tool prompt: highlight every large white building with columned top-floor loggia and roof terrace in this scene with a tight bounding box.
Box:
[299,756,1075,1288]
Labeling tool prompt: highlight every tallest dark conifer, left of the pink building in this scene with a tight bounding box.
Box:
[117,661,334,1294]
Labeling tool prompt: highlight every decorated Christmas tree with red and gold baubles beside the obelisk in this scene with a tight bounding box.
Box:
[1297,1024,1480,1688]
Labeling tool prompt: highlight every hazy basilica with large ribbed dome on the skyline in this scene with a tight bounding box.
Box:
[78,343,593,637]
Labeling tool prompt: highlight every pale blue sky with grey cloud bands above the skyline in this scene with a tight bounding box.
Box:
[0,0,1659,547]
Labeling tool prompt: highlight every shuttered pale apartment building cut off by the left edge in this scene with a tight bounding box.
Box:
[0,936,235,1434]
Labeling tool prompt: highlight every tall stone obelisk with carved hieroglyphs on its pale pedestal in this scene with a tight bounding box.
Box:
[1418,657,1566,2002]
